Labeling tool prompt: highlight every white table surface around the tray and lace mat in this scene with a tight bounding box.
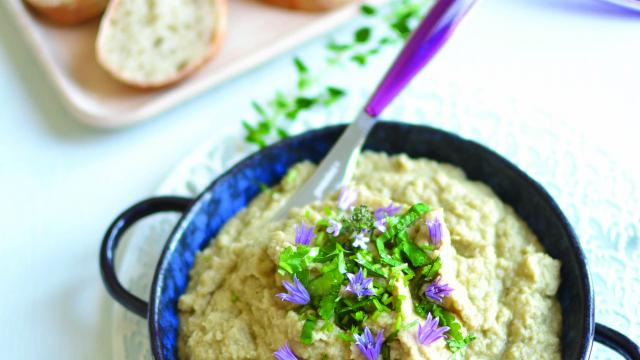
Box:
[0,0,640,359]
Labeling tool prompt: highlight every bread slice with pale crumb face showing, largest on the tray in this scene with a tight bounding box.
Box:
[96,0,227,89]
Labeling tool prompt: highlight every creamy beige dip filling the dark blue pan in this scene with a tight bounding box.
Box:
[178,152,562,359]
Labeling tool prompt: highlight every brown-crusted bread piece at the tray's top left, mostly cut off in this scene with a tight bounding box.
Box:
[25,0,108,25]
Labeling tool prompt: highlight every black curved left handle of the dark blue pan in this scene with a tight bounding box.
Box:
[100,196,193,318]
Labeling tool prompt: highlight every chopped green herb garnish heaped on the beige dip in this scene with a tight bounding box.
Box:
[278,198,474,359]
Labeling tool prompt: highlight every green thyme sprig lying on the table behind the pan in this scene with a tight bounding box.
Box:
[242,0,433,148]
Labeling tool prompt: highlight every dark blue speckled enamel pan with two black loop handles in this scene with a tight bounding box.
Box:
[100,122,640,360]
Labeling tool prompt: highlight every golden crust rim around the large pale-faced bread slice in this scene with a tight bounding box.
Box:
[96,0,227,90]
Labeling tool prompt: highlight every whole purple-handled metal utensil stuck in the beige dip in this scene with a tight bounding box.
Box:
[273,0,476,221]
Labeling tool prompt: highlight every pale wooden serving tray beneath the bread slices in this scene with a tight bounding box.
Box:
[3,0,368,128]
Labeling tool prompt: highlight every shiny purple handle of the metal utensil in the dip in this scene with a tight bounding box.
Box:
[364,0,476,117]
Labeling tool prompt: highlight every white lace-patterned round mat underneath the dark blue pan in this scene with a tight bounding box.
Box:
[113,83,640,359]
